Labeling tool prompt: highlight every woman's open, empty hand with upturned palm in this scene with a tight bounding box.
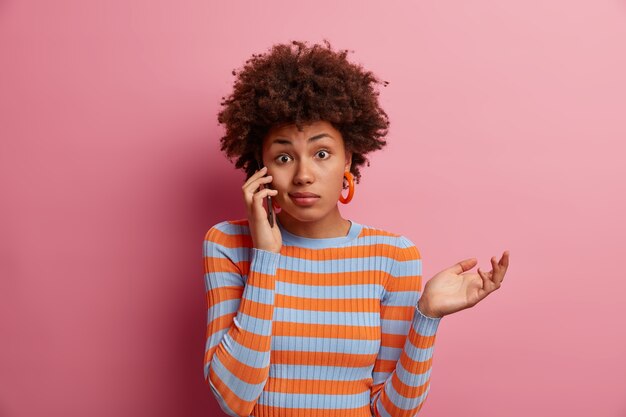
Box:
[418,251,509,318]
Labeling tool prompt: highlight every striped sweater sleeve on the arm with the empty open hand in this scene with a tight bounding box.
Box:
[370,236,441,417]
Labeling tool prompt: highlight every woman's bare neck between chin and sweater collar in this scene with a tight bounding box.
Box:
[276,207,350,239]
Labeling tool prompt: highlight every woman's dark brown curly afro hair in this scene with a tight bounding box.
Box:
[218,39,389,183]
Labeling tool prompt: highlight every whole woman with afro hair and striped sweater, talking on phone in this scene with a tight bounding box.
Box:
[204,41,508,417]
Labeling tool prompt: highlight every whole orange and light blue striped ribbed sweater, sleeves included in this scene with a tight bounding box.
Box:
[203,219,441,417]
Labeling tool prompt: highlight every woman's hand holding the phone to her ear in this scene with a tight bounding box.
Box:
[241,167,283,253]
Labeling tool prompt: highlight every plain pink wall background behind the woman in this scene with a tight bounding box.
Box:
[0,0,626,417]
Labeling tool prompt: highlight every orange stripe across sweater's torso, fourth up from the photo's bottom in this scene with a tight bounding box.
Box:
[272,321,380,340]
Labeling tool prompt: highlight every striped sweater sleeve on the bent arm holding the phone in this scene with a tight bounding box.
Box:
[203,222,280,417]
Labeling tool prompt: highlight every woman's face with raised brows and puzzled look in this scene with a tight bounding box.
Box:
[263,121,352,221]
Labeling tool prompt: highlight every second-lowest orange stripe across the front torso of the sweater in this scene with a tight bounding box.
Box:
[263,377,372,394]
